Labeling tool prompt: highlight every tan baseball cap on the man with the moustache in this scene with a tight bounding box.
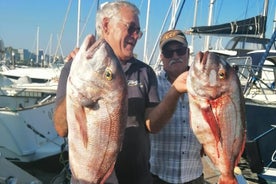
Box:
[159,30,188,49]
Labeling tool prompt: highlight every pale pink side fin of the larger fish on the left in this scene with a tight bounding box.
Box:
[76,108,88,147]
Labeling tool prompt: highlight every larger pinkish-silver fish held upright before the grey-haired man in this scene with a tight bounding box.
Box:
[66,36,127,183]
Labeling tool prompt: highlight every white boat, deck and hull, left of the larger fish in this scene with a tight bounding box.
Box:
[0,76,64,162]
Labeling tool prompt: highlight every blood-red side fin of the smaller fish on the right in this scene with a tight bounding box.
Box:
[201,106,221,143]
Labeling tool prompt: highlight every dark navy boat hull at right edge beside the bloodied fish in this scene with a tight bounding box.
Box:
[246,100,276,170]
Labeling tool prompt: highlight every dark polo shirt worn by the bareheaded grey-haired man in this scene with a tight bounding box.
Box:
[56,58,159,184]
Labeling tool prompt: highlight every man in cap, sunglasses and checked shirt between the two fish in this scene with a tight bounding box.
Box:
[150,30,204,184]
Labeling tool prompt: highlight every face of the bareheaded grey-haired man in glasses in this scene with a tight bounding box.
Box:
[106,7,142,61]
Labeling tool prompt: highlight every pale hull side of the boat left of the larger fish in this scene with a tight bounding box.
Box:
[0,101,64,162]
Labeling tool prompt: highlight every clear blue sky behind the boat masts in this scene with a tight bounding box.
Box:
[0,0,276,62]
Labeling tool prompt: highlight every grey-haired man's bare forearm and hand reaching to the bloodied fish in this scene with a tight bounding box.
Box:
[146,72,188,133]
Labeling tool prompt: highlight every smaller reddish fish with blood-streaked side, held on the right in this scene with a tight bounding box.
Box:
[187,52,246,184]
